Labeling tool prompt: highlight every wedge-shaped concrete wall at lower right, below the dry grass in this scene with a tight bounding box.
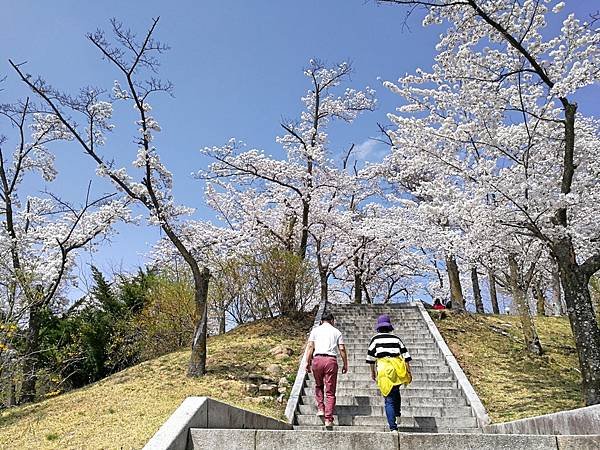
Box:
[483,405,600,436]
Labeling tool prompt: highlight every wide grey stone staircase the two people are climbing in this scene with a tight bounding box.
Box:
[294,304,481,433]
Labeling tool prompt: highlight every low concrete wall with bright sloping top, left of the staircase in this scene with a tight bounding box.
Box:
[144,397,292,450]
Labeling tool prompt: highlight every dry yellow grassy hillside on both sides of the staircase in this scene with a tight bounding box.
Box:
[0,313,583,449]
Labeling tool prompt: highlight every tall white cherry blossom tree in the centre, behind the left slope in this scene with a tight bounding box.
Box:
[204,60,375,314]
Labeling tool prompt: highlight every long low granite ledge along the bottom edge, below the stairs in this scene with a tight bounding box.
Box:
[192,429,600,450]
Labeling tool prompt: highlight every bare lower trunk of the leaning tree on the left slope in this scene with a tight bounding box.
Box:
[188,267,210,377]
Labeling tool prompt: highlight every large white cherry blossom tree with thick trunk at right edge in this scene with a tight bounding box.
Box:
[380,0,600,405]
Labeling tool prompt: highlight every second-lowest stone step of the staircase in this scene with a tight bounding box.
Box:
[299,404,473,422]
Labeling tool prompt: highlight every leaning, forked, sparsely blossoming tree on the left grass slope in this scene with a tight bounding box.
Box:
[11,18,216,376]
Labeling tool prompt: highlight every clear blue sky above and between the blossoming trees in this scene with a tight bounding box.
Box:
[0,0,600,284]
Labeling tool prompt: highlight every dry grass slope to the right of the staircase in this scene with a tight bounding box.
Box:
[432,313,584,422]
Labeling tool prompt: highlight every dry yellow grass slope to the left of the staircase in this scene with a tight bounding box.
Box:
[0,319,310,449]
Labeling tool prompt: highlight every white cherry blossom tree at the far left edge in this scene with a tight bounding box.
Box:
[0,99,129,402]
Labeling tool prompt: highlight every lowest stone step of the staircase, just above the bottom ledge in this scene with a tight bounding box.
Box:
[296,414,477,429]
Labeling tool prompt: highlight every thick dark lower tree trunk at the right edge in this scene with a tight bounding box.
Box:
[552,236,600,406]
